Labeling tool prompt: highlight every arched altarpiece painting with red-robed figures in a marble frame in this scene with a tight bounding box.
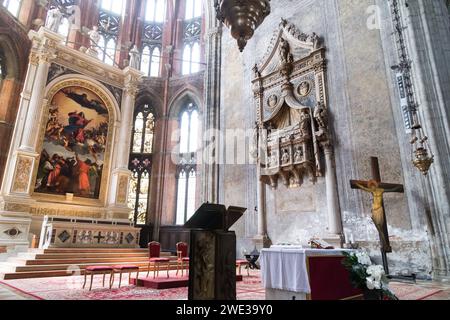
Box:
[35,87,109,199]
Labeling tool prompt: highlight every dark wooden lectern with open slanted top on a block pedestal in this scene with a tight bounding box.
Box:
[184,203,247,300]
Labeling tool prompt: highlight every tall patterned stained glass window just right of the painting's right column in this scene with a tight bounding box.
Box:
[128,104,155,225]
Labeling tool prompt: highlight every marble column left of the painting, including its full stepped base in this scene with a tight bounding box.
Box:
[0,27,63,250]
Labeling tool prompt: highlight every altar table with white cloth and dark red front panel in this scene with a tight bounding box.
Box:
[260,246,362,300]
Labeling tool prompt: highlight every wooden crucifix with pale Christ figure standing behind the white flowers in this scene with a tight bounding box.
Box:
[350,157,405,275]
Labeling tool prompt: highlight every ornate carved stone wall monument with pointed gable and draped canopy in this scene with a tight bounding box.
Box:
[252,19,330,188]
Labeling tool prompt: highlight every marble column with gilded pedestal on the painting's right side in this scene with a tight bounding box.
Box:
[107,67,142,219]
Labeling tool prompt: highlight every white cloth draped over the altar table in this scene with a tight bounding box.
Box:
[260,247,352,294]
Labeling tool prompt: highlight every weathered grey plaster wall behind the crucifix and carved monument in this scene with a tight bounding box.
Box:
[220,0,448,274]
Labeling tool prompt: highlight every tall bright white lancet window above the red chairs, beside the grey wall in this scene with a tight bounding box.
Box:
[176,103,199,225]
